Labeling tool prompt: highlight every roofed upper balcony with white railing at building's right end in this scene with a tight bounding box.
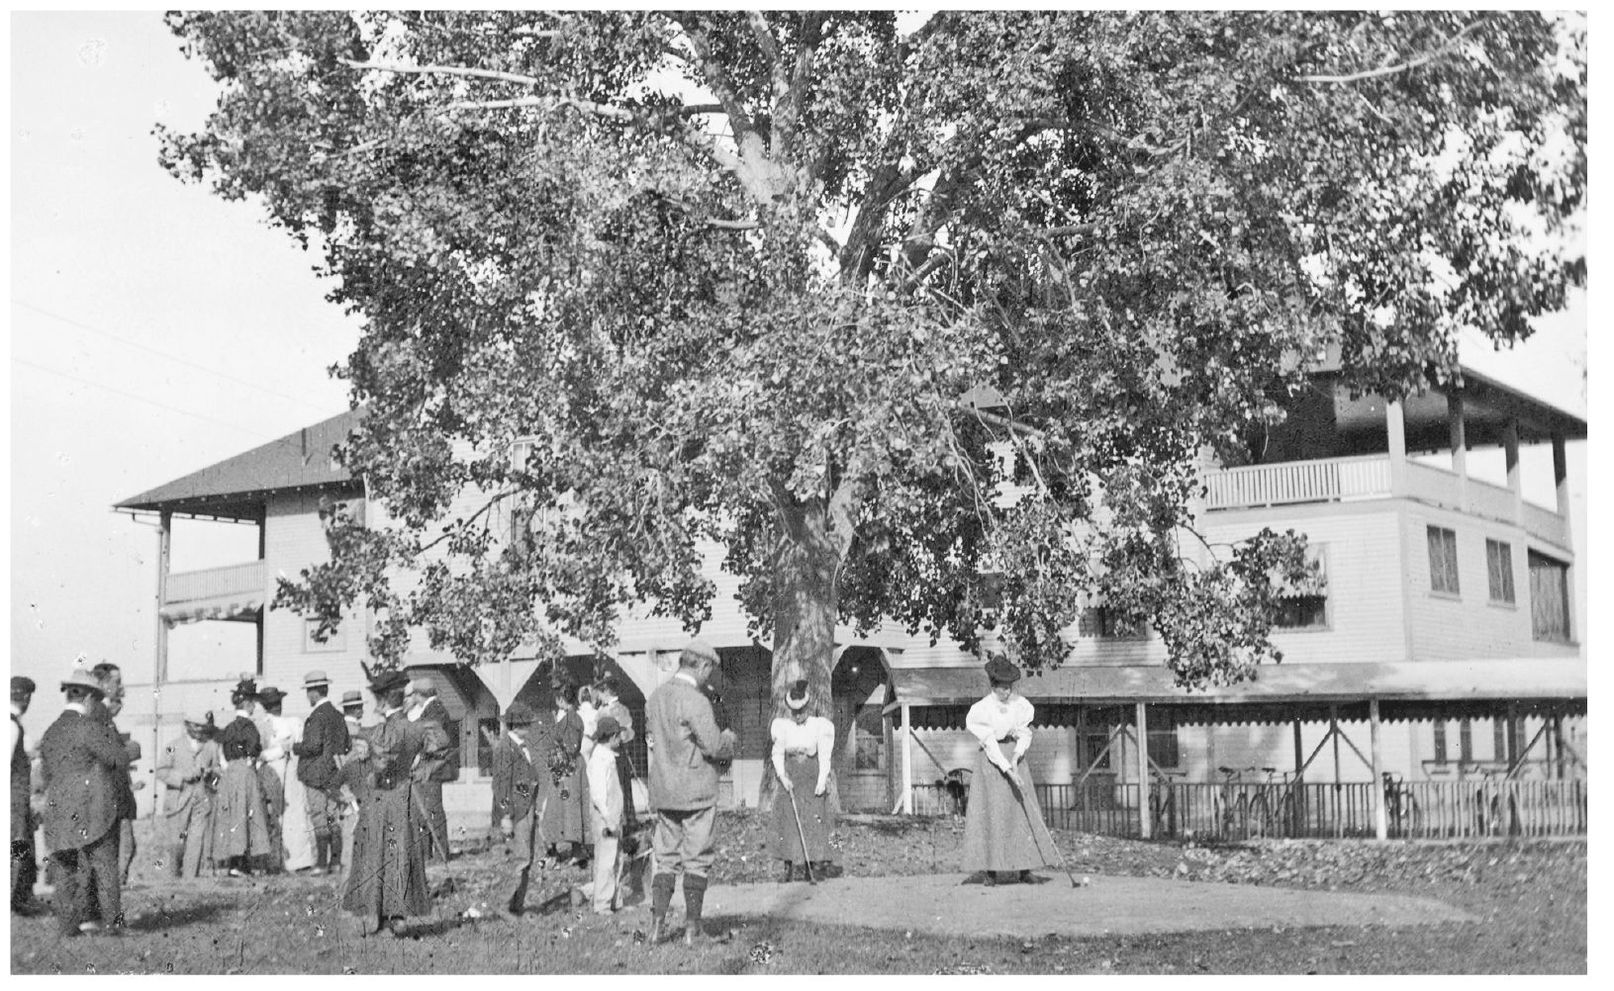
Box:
[1206,370,1587,550]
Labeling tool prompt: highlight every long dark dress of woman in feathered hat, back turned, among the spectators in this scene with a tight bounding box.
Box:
[342,710,449,922]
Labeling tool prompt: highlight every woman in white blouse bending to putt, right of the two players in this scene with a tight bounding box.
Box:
[964,655,1059,884]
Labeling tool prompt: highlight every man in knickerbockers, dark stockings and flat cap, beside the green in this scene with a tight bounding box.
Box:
[644,641,734,944]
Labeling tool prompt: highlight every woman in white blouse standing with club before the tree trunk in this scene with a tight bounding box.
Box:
[773,681,839,881]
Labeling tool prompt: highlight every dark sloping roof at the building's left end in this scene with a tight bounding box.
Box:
[113,408,363,520]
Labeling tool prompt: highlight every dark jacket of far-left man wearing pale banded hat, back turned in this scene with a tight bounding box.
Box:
[39,709,129,851]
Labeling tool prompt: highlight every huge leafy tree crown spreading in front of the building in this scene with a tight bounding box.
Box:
[163,11,1585,713]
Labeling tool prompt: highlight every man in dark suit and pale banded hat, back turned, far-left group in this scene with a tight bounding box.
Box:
[39,668,129,936]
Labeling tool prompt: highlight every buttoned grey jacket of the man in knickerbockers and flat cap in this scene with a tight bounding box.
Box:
[644,675,734,810]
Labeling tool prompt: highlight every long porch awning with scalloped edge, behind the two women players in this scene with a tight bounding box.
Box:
[886,657,1587,718]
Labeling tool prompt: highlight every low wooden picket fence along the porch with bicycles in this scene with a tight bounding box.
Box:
[914,778,1587,841]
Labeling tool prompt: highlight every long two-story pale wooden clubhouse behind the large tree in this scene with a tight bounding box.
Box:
[116,364,1587,833]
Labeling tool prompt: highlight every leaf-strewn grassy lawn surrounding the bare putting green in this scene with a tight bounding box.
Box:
[11,812,1587,973]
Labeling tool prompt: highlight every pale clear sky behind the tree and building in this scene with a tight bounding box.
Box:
[5,13,1587,703]
